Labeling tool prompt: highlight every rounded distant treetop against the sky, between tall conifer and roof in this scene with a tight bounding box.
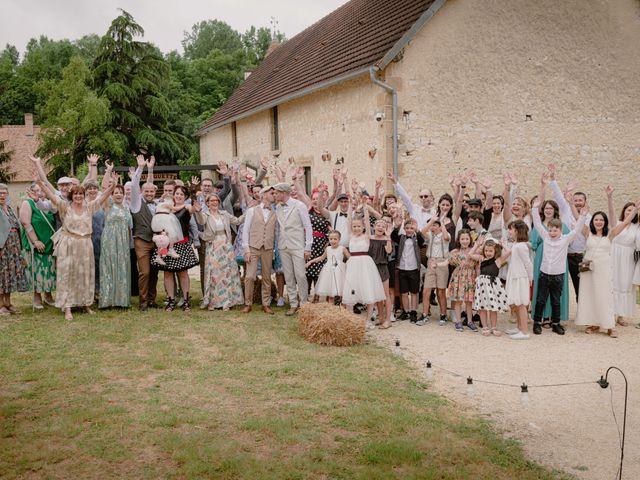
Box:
[182,20,243,60]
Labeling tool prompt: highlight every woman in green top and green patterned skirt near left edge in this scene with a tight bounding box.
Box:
[20,183,56,310]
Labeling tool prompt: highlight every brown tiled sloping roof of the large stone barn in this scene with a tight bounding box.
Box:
[198,0,444,135]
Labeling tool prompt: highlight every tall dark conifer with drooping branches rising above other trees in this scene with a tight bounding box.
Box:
[93,10,189,163]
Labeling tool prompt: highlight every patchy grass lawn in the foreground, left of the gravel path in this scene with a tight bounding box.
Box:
[0,288,570,480]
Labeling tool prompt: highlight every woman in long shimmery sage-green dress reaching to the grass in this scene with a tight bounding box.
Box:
[98,185,132,308]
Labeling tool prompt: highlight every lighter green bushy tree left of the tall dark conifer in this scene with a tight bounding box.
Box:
[38,56,111,176]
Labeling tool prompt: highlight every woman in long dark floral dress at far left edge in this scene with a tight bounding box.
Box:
[0,183,29,315]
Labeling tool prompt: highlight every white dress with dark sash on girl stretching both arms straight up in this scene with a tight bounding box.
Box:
[342,235,386,305]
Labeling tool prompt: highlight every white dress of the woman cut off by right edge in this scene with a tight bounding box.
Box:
[611,223,640,318]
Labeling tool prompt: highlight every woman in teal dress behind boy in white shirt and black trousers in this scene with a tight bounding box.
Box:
[530,200,569,322]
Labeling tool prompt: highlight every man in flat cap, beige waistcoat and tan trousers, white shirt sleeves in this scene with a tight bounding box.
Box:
[242,187,278,315]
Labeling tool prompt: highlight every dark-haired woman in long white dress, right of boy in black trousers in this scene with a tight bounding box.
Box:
[576,212,618,338]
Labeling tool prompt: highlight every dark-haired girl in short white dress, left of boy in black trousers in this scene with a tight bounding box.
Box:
[506,220,533,340]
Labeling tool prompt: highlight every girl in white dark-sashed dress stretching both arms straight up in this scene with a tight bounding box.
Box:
[342,196,386,326]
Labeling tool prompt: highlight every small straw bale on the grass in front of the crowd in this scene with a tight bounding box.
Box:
[298,303,366,347]
